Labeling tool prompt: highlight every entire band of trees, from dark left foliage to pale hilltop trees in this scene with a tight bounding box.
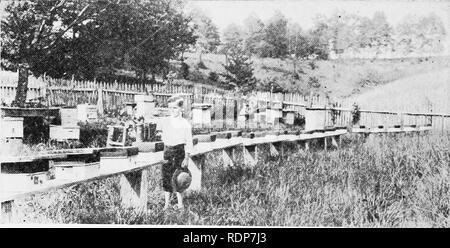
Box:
[0,0,446,101]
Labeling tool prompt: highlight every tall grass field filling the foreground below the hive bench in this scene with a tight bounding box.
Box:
[14,134,450,227]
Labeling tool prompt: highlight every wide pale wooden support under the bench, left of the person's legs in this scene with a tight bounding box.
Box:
[120,169,148,211]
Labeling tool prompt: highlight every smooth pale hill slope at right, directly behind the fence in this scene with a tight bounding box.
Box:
[349,68,450,113]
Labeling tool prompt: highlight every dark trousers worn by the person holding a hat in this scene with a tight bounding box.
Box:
[161,144,185,192]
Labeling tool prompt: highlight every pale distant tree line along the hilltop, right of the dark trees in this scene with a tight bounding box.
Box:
[198,11,446,59]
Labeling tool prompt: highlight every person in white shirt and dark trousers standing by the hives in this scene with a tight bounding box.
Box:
[160,96,193,210]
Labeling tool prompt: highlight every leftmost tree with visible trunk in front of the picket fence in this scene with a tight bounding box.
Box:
[1,0,97,106]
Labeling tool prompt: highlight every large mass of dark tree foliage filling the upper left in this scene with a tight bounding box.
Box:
[1,0,195,79]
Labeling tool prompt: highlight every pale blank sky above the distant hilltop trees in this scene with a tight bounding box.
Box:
[185,0,450,33]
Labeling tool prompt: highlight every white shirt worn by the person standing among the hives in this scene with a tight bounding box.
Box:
[158,116,194,153]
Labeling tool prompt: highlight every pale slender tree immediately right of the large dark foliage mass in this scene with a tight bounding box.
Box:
[190,9,220,62]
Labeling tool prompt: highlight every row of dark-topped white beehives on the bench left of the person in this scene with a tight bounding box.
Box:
[0,147,138,191]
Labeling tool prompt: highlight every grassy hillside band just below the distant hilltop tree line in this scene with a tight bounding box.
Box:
[185,53,450,99]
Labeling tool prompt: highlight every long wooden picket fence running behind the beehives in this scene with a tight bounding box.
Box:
[0,73,450,130]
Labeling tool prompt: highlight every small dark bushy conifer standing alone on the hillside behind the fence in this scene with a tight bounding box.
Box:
[222,42,256,94]
